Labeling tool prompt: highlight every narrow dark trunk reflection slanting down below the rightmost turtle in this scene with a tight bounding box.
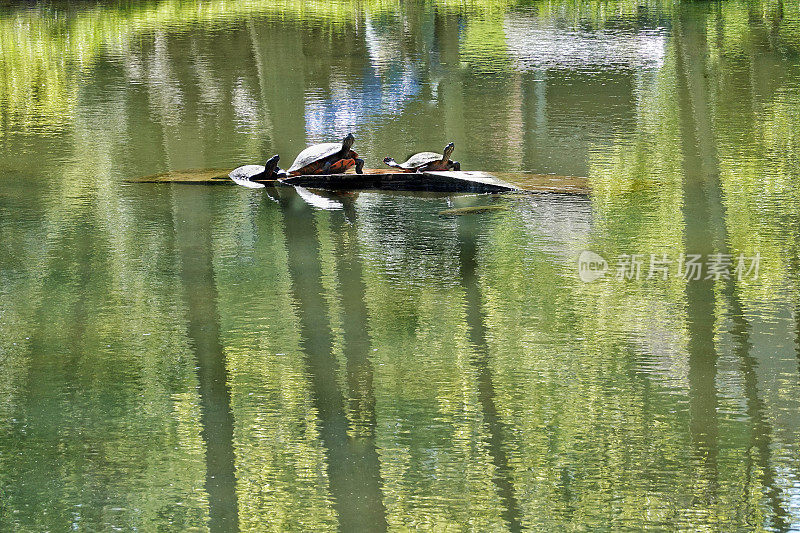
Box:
[458,210,522,531]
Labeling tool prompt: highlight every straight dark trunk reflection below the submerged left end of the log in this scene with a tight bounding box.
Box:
[174,186,239,532]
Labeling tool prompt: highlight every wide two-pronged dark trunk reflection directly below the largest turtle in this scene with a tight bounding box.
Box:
[280,189,387,532]
